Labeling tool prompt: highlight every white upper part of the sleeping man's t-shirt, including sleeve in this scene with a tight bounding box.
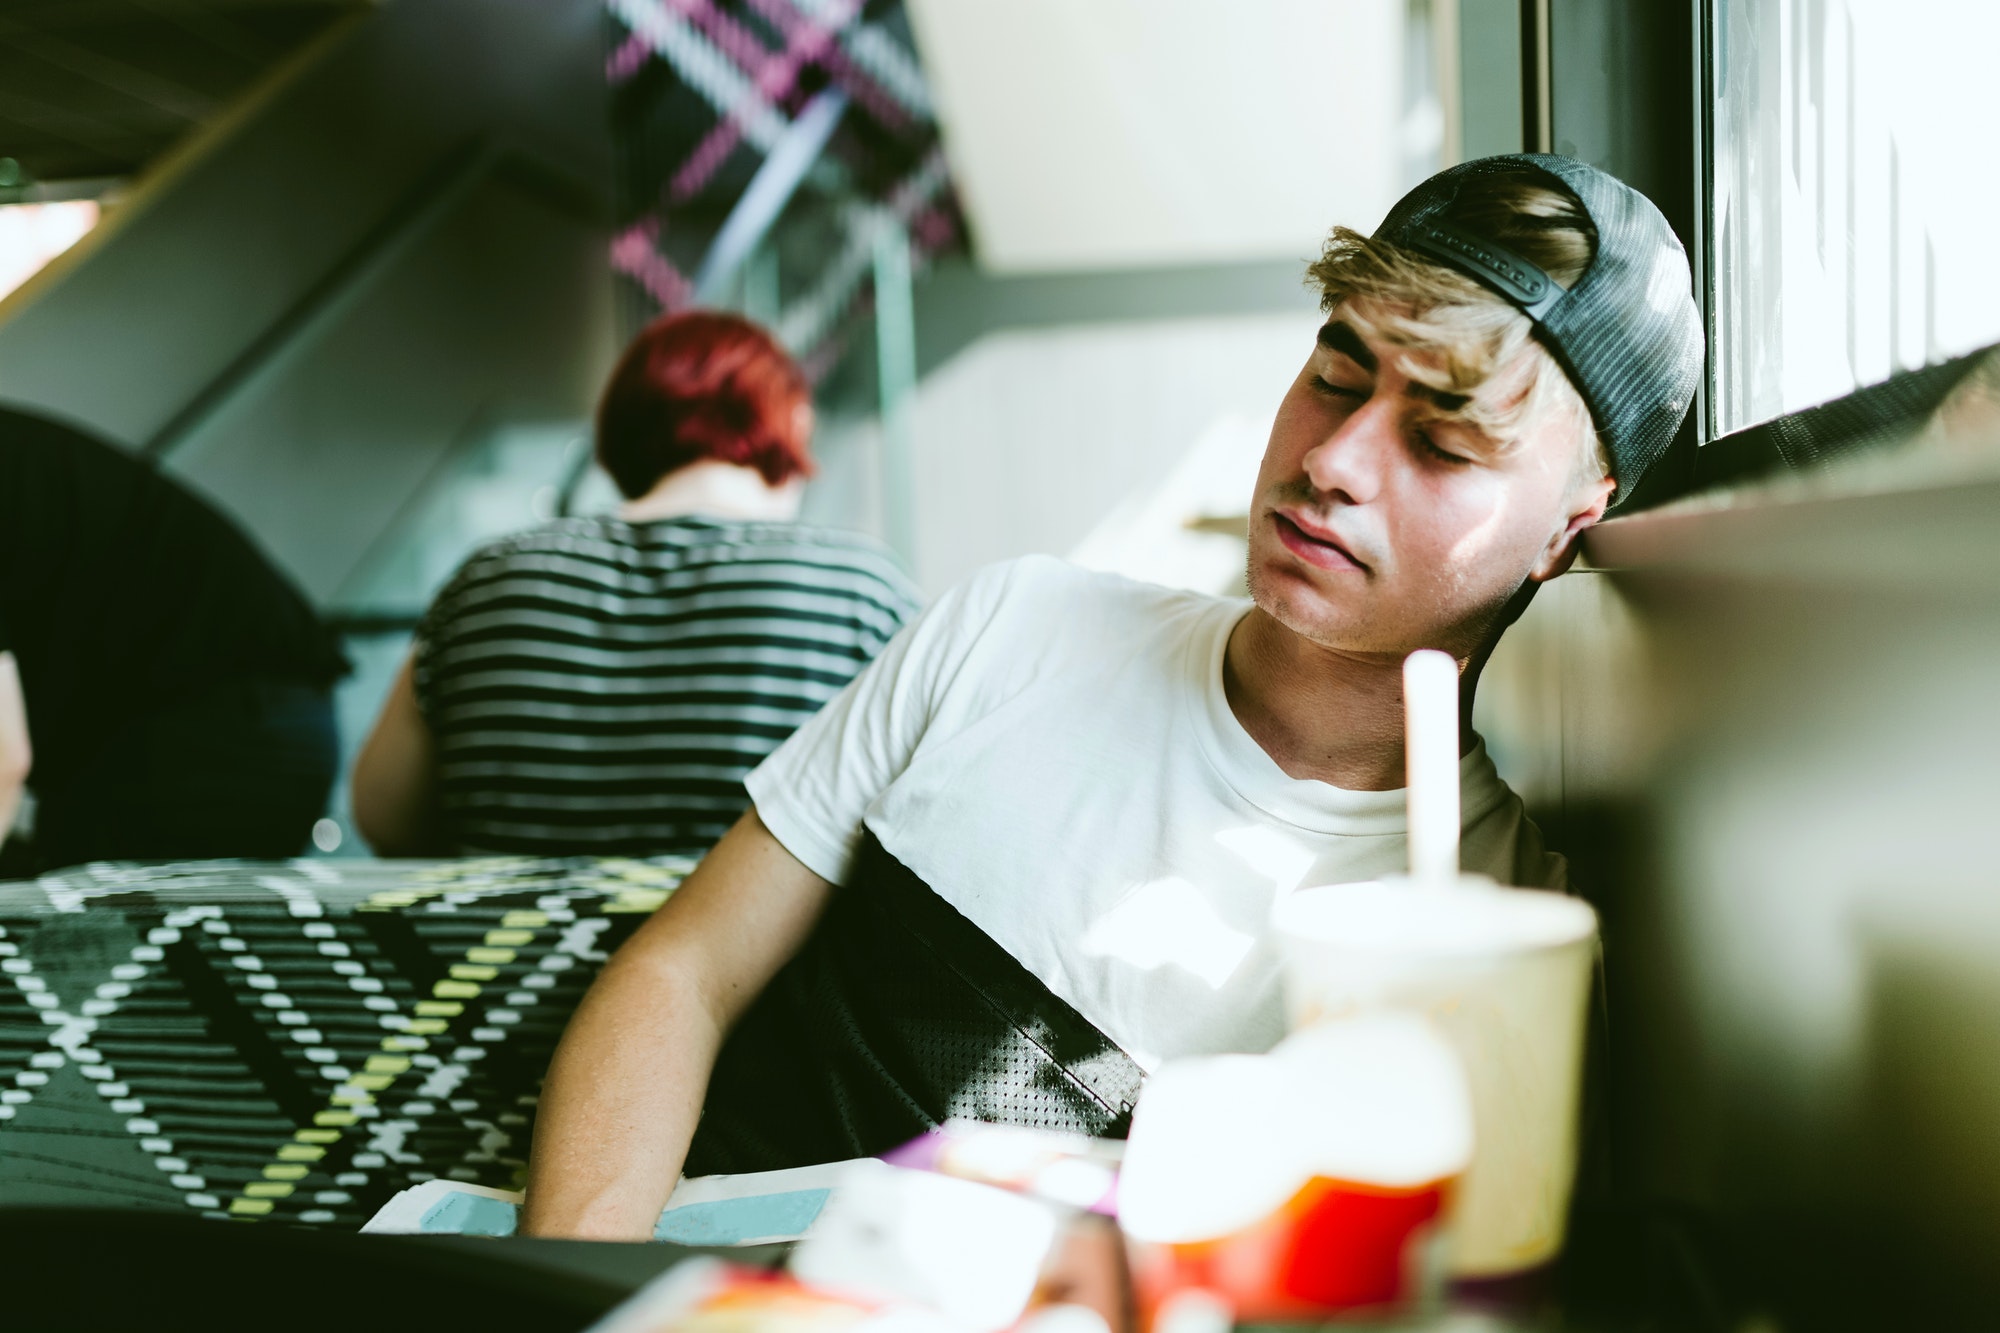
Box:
[748,556,1564,1069]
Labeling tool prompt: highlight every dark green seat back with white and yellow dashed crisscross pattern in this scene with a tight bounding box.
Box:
[0,859,688,1227]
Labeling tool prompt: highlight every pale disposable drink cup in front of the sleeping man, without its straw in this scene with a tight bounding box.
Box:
[1274,875,1598,1279]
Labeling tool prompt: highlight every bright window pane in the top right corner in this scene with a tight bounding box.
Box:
[1710,0,2000,434]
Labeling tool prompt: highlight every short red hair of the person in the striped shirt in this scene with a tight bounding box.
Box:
[598,310,814,500]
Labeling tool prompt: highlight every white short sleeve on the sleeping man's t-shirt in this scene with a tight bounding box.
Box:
[744,564,1012,885]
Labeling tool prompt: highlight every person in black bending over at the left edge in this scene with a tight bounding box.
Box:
[0,408,346,873]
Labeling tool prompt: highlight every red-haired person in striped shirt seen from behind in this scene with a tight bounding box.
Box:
[352,312,916,855]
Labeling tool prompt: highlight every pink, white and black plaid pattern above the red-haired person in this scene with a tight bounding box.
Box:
[604,0,964,378]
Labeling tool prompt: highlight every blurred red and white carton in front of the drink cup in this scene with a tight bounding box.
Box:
[1120,1015,1472,1319]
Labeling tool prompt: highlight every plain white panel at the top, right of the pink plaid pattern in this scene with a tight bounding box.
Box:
[908,0,1406,272]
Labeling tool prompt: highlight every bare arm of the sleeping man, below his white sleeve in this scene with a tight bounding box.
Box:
[522,809,832,1241]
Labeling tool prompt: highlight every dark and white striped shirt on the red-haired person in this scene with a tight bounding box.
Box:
[416,518,918,855]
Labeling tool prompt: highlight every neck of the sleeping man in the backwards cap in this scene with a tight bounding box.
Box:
[1222,606,1478,791]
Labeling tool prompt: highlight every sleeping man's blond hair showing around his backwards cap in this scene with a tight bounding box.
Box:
[1306,170,1610,480]
